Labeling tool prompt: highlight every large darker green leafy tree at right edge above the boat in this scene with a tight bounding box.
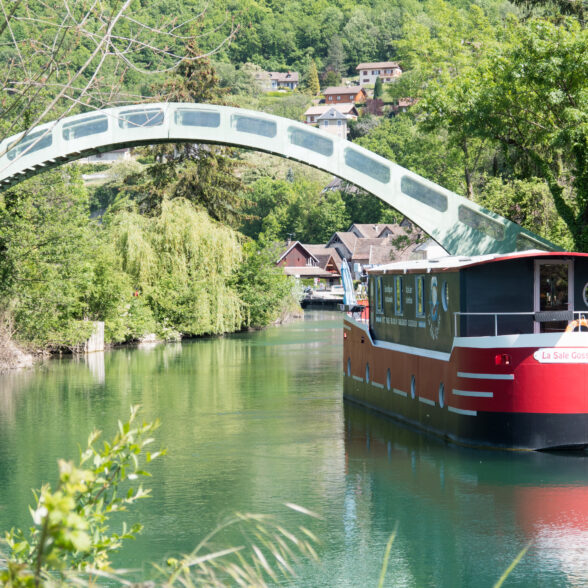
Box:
[460,20,588,251]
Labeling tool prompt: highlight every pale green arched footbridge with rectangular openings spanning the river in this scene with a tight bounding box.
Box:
[0,103,559,255]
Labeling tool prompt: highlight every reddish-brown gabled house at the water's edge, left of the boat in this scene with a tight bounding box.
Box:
[276,241,341,285]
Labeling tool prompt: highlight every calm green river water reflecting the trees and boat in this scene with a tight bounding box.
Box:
[0,313,588,587]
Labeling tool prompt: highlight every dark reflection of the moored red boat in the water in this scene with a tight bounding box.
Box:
[345,403,588,586]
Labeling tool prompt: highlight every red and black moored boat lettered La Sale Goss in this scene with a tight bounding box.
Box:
[344,251,588,450]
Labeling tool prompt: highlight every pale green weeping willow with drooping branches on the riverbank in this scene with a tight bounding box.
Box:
[108,198,242,337]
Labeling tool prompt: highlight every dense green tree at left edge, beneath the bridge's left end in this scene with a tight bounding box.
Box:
[0,167,98,349]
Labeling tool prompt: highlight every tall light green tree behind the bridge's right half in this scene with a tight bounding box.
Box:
[388,0,500,198]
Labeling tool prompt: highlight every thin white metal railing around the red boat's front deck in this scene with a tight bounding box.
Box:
[453,310,588,337]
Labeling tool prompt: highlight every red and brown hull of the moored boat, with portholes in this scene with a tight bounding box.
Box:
[344,319,588,450]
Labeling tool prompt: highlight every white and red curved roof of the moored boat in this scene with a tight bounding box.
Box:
[367,249,588,274]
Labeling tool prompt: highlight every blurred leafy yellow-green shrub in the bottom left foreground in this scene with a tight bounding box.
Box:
[0,406,165,586]
